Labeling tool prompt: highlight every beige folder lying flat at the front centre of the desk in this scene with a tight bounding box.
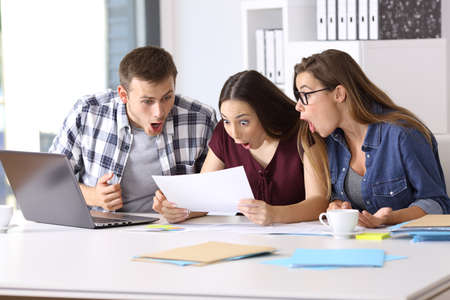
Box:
[135,242,275,264]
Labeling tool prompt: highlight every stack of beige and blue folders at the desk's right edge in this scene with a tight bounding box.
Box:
[390,215,450,242]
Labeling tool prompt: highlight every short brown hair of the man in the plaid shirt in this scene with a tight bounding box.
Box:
[119,46,178,90]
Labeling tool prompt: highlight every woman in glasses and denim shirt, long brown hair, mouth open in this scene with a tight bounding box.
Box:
[294,50,450,227]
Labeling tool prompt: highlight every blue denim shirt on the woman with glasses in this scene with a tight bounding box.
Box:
[326,116,450,214]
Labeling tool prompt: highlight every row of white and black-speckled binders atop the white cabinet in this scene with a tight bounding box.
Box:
[316,0,442,40]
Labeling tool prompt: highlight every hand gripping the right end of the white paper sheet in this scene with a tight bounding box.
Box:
[238,199,274,225]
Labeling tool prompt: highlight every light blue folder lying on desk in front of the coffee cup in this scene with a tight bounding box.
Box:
[291,248,384,267]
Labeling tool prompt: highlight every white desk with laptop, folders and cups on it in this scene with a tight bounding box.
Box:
[0,212,450,299]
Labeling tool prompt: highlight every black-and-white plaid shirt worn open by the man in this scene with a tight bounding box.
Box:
[49,90,217,186]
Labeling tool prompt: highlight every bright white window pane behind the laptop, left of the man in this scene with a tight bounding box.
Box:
[1,0,106,151]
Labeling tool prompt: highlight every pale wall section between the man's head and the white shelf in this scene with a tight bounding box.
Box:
[161,0,242,111]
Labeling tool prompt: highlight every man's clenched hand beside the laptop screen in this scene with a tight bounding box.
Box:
[94,173,123,211]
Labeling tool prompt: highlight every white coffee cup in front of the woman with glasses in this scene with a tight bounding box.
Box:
[319,209,359,238]
